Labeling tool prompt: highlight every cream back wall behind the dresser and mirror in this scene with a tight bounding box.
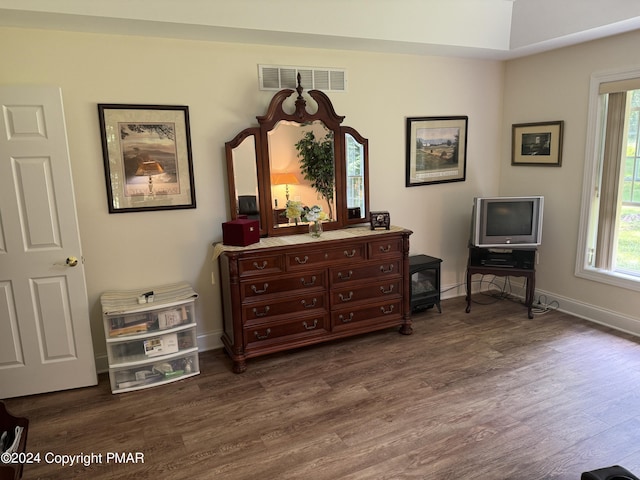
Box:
[0,28,504,368]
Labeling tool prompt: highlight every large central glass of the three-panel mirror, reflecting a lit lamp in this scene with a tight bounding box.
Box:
[267,120,336,228]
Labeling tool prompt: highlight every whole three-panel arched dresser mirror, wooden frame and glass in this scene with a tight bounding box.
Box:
[225,74,369,236]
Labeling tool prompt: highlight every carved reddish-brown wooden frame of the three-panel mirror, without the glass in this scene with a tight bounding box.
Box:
[225,80,369,237]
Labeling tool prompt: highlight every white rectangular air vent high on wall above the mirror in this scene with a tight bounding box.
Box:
[258,65,347,92]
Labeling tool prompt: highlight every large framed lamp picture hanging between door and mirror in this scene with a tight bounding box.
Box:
[98,103,196,213]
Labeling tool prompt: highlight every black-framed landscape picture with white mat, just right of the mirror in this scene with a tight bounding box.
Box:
[406,116,468,187]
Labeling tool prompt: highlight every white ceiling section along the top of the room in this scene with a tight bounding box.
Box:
[0,0,640,60]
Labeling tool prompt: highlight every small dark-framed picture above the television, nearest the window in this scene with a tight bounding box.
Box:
[511,120,564,167]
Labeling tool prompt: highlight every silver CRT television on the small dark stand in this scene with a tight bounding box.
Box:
[471,196,544,248]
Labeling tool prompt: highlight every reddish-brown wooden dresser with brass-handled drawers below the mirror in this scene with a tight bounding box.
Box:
[214,227,412,373]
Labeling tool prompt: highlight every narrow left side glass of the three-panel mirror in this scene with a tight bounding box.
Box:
[232,136,260,225]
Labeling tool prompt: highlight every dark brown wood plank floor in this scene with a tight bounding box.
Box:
[6,297,640,480]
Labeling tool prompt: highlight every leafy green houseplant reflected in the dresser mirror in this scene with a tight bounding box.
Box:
[295,131,335,219]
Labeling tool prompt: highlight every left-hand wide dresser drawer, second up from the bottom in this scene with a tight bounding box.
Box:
[242,291,327,325]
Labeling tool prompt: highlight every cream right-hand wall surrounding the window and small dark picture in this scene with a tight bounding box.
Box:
[500,31,640,334]
